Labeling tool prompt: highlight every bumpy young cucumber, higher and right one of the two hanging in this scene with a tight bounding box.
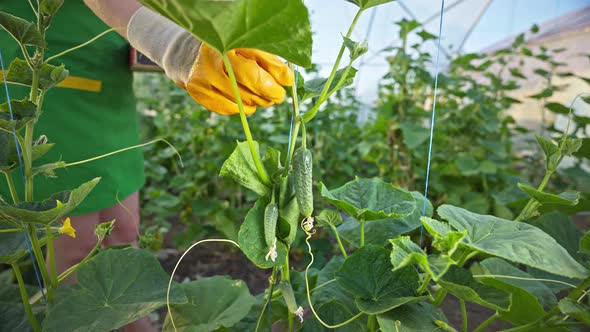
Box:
[293,148,313,217]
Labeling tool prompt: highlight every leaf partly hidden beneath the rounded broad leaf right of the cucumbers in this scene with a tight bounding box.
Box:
[340,191,433,248]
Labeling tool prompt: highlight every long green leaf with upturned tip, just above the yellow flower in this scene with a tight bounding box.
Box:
[0,178,100,225]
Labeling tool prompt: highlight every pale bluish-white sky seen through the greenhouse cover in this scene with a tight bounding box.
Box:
[305,0,590,103]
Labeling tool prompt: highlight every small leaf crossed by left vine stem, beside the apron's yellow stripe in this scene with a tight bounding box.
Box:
[0,58,69,90]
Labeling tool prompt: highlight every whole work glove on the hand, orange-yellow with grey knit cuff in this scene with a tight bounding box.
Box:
[127,7,294,115]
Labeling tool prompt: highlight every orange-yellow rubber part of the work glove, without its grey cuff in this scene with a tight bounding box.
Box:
[181,43,294,115]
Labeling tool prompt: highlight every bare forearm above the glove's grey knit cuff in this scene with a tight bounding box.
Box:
[84,0,141,38]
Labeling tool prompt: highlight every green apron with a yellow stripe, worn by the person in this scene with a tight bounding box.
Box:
[0,0,145,215]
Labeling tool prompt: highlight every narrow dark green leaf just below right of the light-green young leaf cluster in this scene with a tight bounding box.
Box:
[438,266,510,310]
